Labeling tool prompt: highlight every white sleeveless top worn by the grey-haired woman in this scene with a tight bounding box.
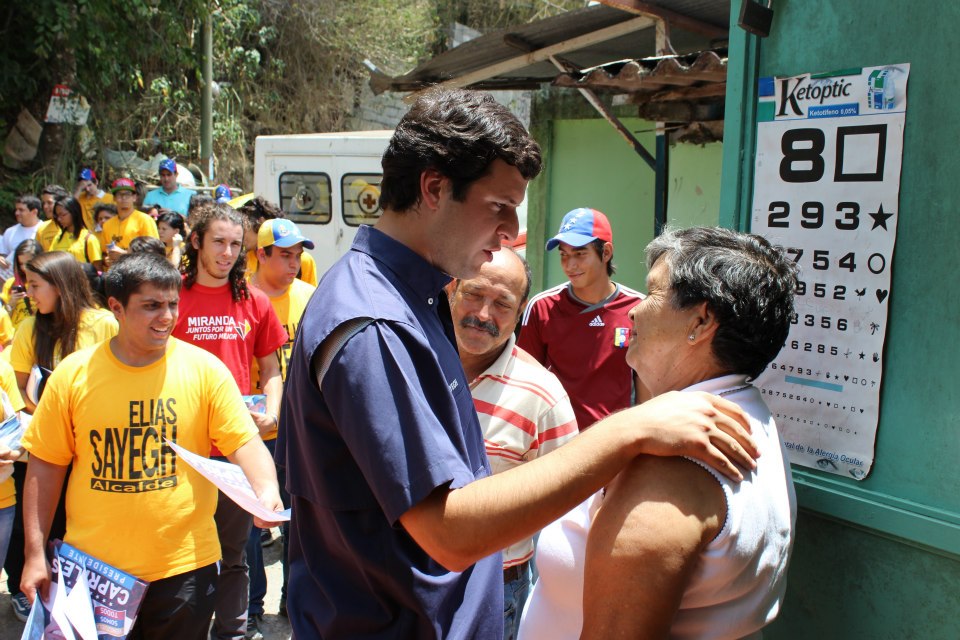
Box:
[519,376,797,640]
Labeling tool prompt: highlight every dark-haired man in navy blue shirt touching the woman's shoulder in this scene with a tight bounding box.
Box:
[276,90,756,640]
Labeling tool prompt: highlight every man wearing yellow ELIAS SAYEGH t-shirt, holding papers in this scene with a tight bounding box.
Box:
[21,253,282,640]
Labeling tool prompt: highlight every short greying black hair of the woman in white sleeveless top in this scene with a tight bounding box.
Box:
[647,227,797,378]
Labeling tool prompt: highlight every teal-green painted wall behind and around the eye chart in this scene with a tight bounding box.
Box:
[721,0,960,640]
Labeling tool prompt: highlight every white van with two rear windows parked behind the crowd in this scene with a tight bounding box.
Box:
[253,130,393,275]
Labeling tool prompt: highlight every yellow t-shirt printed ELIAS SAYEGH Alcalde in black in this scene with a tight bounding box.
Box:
[23,338,257,582]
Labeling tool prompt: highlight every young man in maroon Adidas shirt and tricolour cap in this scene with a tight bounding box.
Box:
[517,208,646,430]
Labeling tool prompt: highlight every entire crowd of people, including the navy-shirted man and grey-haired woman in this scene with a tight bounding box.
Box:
[0,90,796,640]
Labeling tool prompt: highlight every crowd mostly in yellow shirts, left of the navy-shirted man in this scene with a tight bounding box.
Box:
[0,160,316,638]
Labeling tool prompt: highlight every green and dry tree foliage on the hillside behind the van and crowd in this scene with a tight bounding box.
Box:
[0,0,583,206]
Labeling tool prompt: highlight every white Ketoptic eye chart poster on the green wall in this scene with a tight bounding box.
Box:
[751,64,910,480]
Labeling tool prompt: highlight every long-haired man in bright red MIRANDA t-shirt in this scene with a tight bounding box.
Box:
[173,203,287,640]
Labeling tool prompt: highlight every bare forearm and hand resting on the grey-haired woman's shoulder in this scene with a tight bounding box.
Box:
[400,393,757,571]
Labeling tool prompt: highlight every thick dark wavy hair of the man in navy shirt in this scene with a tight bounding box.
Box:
[380,89,542,212]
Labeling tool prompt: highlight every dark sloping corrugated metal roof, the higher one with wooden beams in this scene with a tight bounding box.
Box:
[370,0,730,93]
